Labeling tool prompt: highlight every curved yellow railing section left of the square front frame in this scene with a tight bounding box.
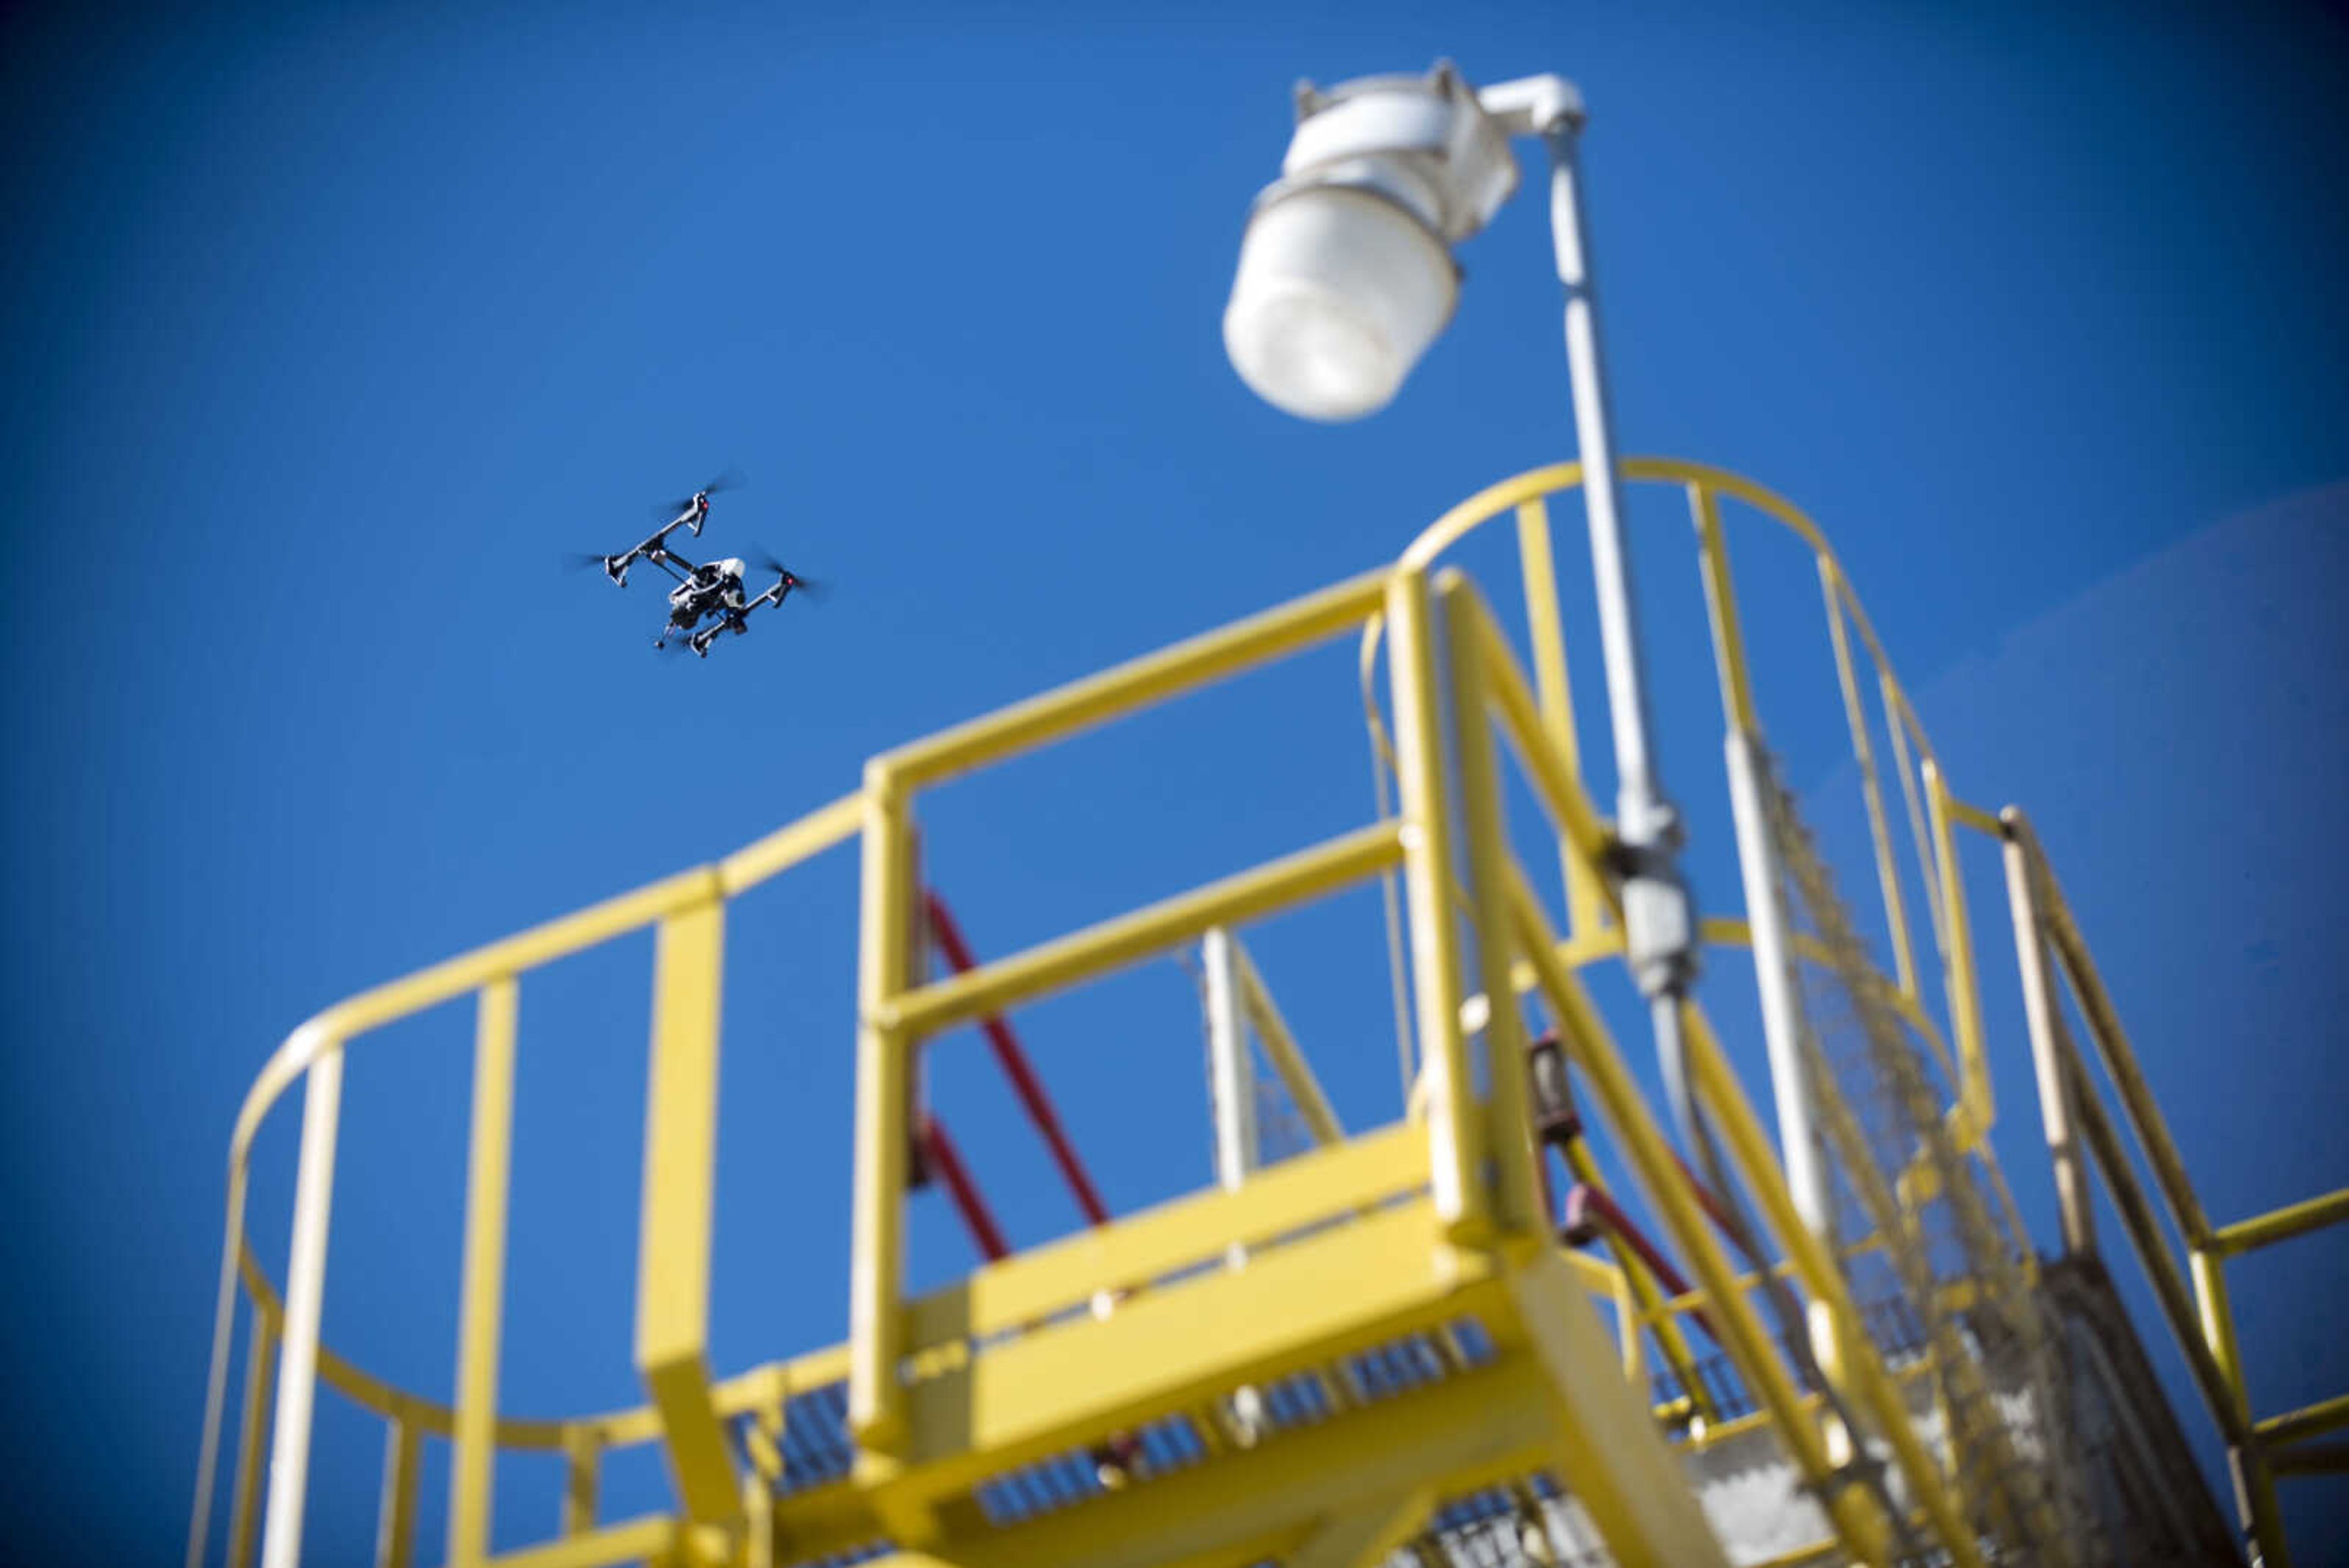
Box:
[188,797,858,1568]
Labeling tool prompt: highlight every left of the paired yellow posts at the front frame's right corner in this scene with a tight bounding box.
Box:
[1386,569,1494,1246]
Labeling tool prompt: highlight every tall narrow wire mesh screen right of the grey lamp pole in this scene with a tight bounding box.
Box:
[1759,764,2102,1566]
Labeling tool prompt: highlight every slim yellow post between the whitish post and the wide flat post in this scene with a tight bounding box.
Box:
[448,976,517,1568]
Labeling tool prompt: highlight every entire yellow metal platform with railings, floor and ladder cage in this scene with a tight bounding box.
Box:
[188,458,2349,1568]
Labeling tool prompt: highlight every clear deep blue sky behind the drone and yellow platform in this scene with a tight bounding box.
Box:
[0,5,2349,1561]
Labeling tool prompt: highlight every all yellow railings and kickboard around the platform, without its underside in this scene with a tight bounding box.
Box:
[188,458,2349,1568]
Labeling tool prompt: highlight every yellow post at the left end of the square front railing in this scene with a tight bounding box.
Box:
[848,762,914,1455]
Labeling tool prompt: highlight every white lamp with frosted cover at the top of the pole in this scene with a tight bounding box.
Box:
[1224,64,1518,421]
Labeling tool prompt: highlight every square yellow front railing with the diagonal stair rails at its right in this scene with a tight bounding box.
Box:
[850,524,2011,1561]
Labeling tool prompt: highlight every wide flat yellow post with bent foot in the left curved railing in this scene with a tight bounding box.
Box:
[637,893,742,1523]
